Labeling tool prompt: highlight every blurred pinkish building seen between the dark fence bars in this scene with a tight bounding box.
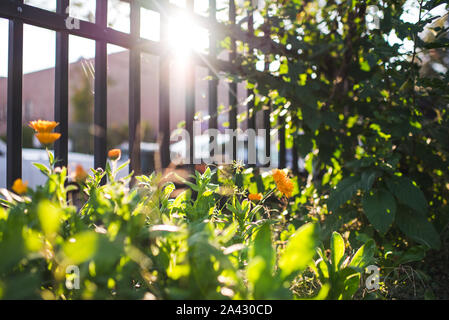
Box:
[0,51,246,145]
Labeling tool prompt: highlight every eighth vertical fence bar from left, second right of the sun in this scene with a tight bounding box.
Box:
[229,0,238,160]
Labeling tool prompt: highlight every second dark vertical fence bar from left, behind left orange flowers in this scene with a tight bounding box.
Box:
[55,0,69,167]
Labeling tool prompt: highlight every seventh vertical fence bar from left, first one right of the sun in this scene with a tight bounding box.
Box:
[208,0,218,159]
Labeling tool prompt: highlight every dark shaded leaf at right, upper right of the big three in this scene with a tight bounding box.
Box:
[386,176,427,215]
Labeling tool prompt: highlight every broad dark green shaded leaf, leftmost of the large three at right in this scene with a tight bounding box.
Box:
[362,189,396,234]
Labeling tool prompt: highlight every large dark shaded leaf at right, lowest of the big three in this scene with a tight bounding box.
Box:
[396,206,441,249]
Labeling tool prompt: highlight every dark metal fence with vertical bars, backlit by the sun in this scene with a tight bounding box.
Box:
[0,0,286,187]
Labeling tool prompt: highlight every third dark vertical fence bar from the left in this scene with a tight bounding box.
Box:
[94,0,108,168]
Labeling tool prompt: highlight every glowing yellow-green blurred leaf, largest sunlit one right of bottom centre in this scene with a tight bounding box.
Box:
[279,223,319,278]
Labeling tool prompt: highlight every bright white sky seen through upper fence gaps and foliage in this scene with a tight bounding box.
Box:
[0,0,445,77]
